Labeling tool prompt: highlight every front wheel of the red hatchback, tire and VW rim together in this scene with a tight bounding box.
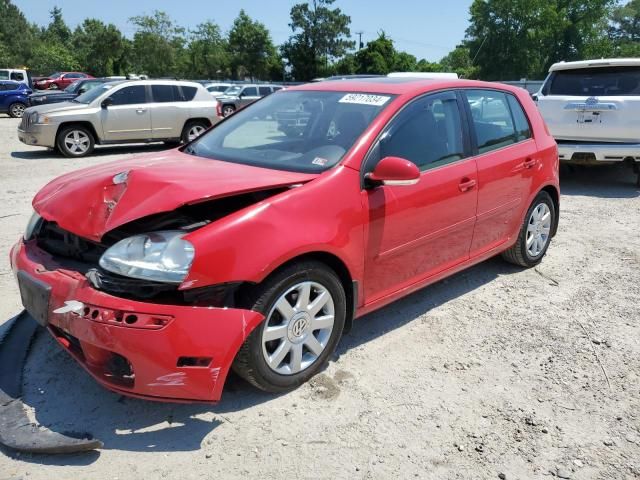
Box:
[233,261,346,392]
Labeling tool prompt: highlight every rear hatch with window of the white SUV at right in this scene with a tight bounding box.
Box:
[538,66,640,143]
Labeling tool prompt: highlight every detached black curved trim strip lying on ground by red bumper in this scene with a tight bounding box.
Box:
[0,311,103,454]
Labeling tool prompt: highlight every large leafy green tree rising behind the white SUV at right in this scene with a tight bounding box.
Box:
[464,0,615,80]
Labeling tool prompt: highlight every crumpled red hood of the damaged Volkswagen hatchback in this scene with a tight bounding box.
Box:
[33,150,317,241]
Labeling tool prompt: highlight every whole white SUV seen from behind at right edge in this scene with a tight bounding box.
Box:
[534,58,640,186]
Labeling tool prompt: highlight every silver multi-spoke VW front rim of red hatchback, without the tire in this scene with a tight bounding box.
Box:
[262,282,335,375]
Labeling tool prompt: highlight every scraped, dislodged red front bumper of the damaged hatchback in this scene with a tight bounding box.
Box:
[11,240,263,402]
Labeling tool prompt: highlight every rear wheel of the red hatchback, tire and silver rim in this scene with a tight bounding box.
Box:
[502,192,557,268]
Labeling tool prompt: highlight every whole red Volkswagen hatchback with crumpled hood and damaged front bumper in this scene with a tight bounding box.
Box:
[11,78,559,401]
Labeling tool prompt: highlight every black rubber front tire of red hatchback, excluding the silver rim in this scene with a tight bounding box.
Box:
[233,261,347,392]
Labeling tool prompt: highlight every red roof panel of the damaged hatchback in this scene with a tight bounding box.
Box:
[287,77,522,95]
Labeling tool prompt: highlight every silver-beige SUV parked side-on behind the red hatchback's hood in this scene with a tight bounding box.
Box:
[18,80,219,157]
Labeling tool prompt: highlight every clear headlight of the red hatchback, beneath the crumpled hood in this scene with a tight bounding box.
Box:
[100,230,195,283]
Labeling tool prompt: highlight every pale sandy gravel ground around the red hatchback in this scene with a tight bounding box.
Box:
[0,118,640,479]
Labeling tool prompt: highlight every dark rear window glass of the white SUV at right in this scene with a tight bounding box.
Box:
[548,67,640,97]
